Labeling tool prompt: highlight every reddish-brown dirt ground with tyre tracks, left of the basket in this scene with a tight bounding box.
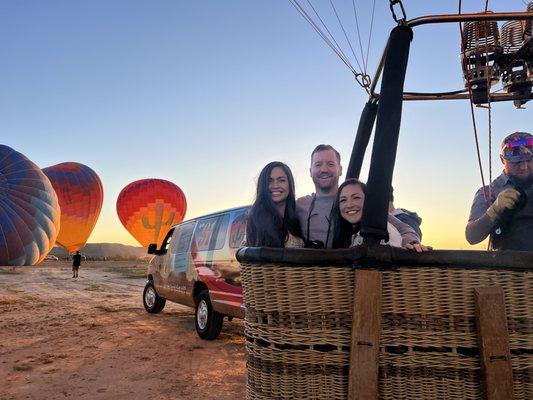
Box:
[0,261,246,400]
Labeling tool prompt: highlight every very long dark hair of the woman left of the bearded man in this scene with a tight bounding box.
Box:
[246,161,302,247]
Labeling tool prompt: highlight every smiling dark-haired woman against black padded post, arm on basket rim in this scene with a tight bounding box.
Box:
[333,179,430,253]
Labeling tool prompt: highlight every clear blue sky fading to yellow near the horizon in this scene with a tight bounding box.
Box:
[0,0,533,248]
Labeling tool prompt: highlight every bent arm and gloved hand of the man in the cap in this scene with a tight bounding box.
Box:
[465,188,520,244]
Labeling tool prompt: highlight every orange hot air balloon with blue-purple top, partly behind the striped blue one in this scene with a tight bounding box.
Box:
[43,162,104,253]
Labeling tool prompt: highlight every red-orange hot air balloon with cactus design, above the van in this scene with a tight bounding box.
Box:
[117,179,187,247]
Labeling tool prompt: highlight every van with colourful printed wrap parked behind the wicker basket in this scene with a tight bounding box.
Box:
[143,207,249,340]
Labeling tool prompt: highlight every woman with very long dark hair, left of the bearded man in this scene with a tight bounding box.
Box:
[246,161,304,247]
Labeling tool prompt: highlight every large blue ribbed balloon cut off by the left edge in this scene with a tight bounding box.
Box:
[0,145,60,266]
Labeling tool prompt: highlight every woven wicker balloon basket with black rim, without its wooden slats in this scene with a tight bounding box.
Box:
[239,247,533,400]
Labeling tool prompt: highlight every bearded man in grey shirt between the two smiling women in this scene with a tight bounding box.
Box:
[296,144,342,249]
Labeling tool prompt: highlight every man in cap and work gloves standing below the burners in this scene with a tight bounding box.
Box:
[465,132,533,251]
